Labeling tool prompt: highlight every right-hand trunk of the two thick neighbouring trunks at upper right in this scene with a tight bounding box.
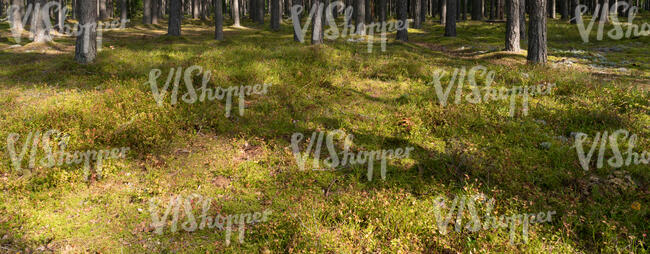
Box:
[527,0,547,64]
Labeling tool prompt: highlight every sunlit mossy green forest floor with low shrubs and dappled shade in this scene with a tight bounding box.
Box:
[0,14,650,253]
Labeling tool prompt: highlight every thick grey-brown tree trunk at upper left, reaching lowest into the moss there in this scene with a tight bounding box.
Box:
[74,0,97,64]
